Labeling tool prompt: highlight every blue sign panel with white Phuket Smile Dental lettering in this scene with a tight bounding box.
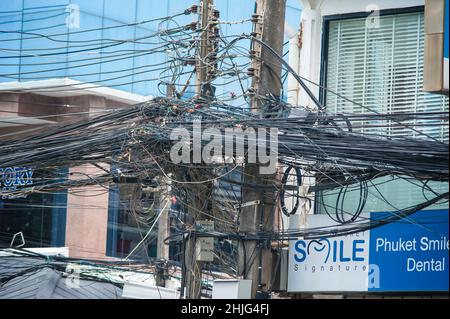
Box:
[368,210,449,291]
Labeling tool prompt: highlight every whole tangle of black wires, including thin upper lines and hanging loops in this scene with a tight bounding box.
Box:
[0,3,449,284]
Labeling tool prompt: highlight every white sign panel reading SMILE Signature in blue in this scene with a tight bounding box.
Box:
[288,215,369,292]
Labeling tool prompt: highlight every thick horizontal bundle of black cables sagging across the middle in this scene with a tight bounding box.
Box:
[0,98,448,215]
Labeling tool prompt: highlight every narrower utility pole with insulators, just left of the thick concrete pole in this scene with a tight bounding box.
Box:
[183,0,218,299]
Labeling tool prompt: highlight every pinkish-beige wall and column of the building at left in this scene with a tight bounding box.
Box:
[0,93,133,259]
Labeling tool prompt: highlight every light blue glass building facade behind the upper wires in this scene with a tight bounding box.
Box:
[0,0,300,95]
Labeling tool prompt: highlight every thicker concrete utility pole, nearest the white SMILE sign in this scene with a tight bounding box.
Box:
[239,0,286,298]
